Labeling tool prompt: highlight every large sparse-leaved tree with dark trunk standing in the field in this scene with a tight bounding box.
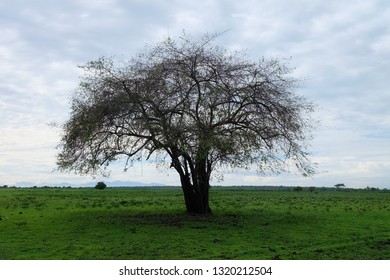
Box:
[57,32,313,214]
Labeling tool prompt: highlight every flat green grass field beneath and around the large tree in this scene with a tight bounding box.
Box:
[0,188,390,260]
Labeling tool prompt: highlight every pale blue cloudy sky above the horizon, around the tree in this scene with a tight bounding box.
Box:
[0,0,390,188]
